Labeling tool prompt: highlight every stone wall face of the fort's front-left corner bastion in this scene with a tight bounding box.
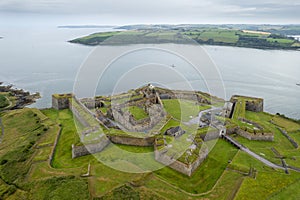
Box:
[72,138,110,158]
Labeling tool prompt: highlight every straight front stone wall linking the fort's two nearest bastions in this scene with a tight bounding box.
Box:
[107,135,155,147]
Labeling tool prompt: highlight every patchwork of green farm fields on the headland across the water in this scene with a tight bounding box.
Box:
[69,27,300,49]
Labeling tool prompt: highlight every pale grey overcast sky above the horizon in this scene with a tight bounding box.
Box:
[0,0,300,25]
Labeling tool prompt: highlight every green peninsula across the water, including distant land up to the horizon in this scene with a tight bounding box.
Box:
[69,25,300,50]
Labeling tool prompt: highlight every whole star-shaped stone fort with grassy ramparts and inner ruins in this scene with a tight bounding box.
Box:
[52,84,274,176]
